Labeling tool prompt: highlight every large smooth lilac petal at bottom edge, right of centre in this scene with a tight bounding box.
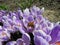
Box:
[34,36,49,45]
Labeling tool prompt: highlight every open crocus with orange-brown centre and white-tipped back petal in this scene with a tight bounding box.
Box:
[18,8,35,32]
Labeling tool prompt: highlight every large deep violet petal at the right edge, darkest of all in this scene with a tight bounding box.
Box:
[50,25,60,43]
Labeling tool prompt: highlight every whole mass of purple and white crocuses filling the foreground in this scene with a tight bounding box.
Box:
[0,6,60,45]
